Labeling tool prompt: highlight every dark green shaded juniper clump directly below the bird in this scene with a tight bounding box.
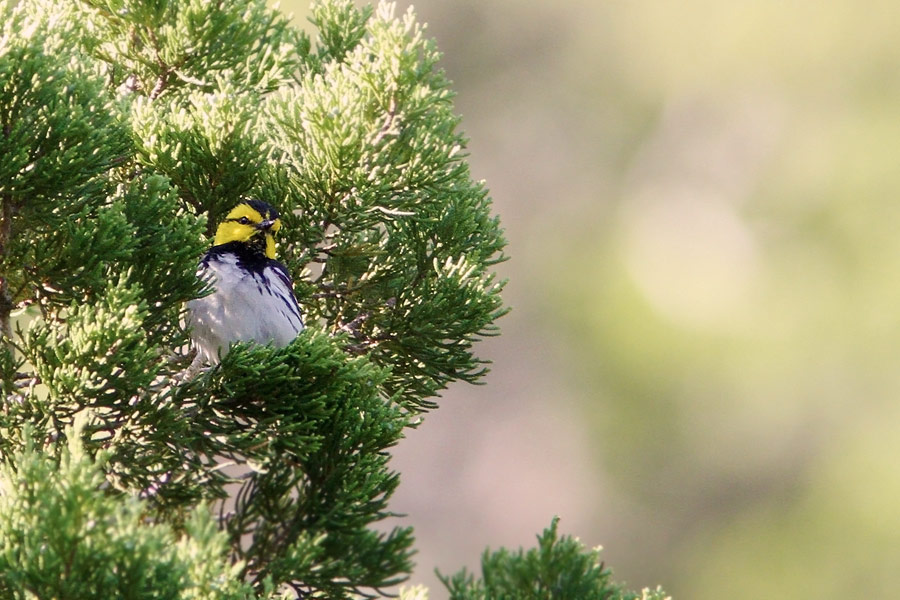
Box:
[174,329,412,598]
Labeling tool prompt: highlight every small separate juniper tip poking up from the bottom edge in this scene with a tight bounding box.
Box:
[441,518,668,600]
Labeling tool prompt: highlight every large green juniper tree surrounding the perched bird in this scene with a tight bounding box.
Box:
[0,0,668,599]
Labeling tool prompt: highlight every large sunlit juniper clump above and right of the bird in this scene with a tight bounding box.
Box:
[267,2,505,408]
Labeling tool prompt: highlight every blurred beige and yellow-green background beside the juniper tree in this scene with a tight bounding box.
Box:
[282,0,900,600]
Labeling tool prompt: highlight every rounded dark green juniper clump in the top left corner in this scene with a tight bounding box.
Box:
[0,1,127,207]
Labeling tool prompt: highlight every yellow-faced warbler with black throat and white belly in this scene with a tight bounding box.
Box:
[187,199,303,365]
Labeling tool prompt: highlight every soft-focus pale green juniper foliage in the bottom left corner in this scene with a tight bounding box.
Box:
[0,419,262,600]
